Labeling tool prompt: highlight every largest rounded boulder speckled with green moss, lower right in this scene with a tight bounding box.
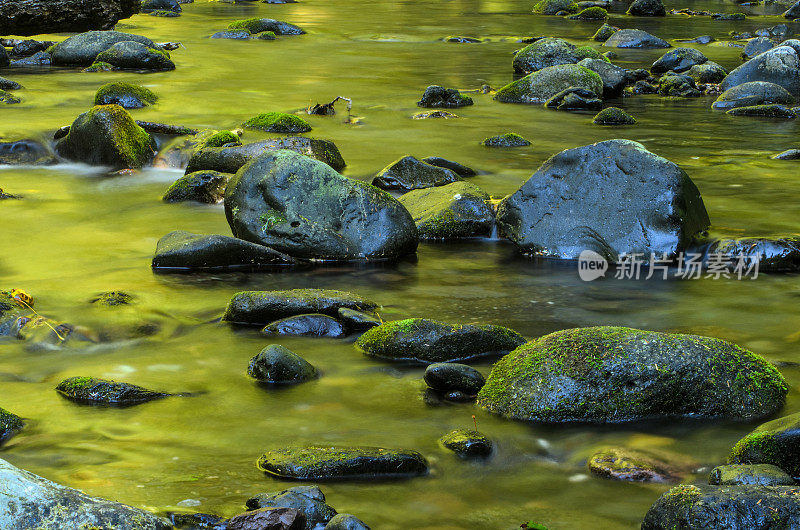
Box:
[478,327,788,423]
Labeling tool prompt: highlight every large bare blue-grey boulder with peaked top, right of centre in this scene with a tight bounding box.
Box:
[497,140,709,260]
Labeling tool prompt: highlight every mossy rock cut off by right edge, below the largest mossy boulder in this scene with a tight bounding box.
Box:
[728,413,800,479]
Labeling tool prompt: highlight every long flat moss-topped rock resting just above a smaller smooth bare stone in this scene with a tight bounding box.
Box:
[222,289,378,326]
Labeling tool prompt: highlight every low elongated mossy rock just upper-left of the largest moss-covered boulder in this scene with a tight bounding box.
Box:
[356,318,525,364]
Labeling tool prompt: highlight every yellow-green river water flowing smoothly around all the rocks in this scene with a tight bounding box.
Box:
[0,0,800,530]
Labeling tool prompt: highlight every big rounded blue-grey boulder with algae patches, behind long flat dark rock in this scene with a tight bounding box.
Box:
[225,150,416,261]
